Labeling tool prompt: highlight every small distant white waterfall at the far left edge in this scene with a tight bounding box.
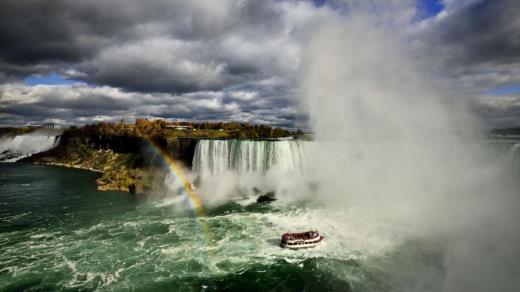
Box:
[0,133,59,162]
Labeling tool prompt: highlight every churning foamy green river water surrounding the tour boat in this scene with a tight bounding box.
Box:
[0,164,441,291]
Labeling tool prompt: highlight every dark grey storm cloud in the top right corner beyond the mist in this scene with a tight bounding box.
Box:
[418,0,520,90]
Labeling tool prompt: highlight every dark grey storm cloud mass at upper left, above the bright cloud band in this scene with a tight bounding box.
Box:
[0,0,304,92]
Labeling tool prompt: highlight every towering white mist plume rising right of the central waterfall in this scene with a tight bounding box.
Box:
[302,6,520,291]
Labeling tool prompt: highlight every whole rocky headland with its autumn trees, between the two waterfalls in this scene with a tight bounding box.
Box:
[20,119,298,193]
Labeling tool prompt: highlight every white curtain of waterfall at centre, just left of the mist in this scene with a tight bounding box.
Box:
[193,140,309,177]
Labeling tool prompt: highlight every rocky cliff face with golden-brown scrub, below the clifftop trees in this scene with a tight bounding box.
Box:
[23,131,197,193]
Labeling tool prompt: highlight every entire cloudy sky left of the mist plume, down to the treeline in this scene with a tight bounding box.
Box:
[0,0,334,125]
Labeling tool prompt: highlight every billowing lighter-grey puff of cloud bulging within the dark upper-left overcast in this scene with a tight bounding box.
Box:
[83,38,232,92]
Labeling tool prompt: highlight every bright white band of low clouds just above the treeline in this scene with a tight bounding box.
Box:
[0,83,304,127]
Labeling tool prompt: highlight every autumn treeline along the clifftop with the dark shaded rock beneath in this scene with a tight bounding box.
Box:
[41,119,302,167]
